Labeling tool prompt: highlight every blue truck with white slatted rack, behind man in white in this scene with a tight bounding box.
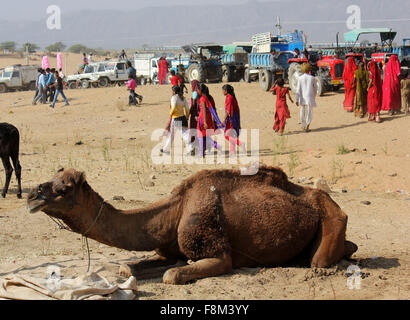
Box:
[244,30,305,91]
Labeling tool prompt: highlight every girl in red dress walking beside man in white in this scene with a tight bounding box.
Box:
[270,78,293,135]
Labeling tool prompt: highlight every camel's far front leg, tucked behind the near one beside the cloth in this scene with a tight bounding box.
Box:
[119,255,181,280]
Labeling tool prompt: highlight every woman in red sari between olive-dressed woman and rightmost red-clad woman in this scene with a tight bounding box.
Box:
[367,61,383,122]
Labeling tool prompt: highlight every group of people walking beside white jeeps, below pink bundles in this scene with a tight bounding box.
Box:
[33,68,70,108]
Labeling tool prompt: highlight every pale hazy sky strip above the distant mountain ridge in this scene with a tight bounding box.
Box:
[0,0,258,20]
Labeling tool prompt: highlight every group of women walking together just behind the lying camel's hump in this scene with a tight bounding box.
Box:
[161,80,246,157]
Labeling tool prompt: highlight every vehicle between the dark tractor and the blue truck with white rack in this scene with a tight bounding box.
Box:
[221,42,252,82]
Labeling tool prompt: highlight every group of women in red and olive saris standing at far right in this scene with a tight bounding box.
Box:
[343,55,410,123]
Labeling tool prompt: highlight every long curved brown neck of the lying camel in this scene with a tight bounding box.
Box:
[63,183,179,251]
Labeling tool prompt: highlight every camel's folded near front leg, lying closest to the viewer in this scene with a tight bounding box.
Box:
[163,253,232,284]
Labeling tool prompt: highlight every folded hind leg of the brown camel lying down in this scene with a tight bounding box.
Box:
[311,192,357,268]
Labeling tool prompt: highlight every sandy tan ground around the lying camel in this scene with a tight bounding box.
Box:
[0,55,410,299]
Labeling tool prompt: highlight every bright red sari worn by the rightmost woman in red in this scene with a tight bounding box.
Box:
[382,55,401,110]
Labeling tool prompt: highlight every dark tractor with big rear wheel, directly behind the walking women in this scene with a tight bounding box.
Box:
[167,43,223,83]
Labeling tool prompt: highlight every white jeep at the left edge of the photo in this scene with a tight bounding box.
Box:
[0,64,40,93]
